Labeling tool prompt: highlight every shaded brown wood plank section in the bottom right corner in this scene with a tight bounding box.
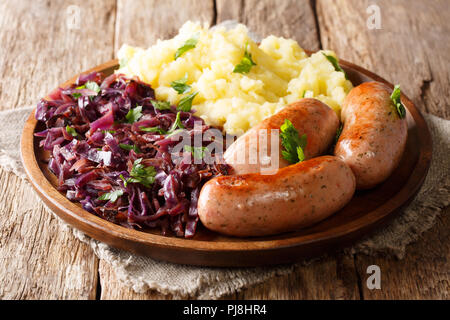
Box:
[356,207,450,300]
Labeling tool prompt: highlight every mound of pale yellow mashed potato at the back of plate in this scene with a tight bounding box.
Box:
[118,22,352,135]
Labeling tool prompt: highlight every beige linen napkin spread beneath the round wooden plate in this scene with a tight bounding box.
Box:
[0,107,450,299]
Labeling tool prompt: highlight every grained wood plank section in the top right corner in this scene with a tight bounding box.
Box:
[317,0,450,119]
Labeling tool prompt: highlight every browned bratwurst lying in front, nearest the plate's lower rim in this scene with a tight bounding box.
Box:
[198,156,355,237]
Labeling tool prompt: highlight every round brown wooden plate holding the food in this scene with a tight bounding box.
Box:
[21,56,432,267]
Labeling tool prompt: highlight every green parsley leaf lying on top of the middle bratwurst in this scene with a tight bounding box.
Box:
[280,119,307,163]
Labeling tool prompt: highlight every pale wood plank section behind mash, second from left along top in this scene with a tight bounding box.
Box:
[115,0,215,52]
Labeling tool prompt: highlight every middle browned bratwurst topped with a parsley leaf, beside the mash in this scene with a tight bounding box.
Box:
[224,98,339,174]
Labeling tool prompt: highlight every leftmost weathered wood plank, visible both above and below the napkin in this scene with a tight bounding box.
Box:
[0,0,115,299]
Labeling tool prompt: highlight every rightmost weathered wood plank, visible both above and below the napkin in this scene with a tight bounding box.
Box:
[317,0,450,299]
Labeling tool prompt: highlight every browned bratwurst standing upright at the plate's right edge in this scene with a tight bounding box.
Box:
[334,82,408,189]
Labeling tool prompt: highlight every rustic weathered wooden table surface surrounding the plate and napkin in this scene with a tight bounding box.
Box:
[0,0,450,299]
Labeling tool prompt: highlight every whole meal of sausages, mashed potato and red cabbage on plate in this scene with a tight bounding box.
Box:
[35,23,408,238]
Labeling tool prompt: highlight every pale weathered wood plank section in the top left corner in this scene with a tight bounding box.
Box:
[0,0,115,109]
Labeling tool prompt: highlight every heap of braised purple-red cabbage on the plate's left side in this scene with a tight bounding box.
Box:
[35,72,229,238]
